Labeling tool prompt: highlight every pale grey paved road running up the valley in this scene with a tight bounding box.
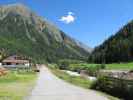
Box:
[28,67,108,100]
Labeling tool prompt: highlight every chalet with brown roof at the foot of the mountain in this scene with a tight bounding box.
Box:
[2,55,30,67]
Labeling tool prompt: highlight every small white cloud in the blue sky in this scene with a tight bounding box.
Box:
[59,12,75,24]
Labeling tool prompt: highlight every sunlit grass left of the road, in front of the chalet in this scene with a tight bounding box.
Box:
[0,71,36,100]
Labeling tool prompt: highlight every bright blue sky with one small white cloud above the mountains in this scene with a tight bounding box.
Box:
[0,0,133,48]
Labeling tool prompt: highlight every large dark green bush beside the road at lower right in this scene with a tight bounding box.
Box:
[91,76,133,100]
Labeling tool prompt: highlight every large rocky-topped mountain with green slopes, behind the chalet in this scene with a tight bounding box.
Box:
[0,4,91,62]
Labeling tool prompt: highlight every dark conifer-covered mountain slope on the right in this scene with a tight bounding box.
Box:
[89,21,133,63]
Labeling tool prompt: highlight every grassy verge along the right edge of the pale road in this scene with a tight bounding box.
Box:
[51,68,119,100]
